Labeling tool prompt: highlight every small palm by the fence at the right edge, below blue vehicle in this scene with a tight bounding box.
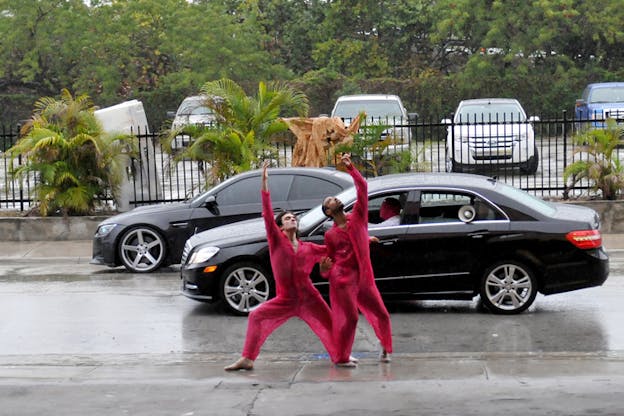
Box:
[563,119,624,200]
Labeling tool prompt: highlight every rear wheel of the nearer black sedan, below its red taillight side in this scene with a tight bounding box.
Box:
[479,260,537,315]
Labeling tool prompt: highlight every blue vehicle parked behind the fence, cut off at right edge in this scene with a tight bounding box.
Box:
[575,82,624,127]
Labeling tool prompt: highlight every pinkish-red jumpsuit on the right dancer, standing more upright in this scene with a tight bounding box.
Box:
[325,165,392,362]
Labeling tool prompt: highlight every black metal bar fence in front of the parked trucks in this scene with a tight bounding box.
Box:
[0,112,624,211]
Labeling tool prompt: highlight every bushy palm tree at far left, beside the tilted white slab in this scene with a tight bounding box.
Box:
[7,89,137,216]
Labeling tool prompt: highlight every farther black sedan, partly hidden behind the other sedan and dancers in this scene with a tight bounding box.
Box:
[91,168,353,273]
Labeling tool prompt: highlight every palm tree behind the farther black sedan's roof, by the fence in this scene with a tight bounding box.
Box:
[165,79,309,183]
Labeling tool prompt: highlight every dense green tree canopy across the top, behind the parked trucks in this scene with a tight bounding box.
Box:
[0,0,624,126]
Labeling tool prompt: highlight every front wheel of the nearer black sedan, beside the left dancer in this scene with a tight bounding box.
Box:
[220,262,275,315]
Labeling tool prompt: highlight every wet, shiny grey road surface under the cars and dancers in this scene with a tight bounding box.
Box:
[0,254,624,355]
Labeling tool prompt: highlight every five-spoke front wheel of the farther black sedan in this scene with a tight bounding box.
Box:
[118,227,167,273]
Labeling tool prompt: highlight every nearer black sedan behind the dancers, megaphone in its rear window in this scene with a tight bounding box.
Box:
[181,173,609,314]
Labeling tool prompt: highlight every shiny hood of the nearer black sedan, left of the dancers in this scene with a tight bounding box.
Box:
[186,218,266,249]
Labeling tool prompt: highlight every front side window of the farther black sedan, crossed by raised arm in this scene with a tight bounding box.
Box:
[217,175,292,206]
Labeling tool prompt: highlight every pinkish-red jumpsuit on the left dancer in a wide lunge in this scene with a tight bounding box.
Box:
[243,191,335,361]
